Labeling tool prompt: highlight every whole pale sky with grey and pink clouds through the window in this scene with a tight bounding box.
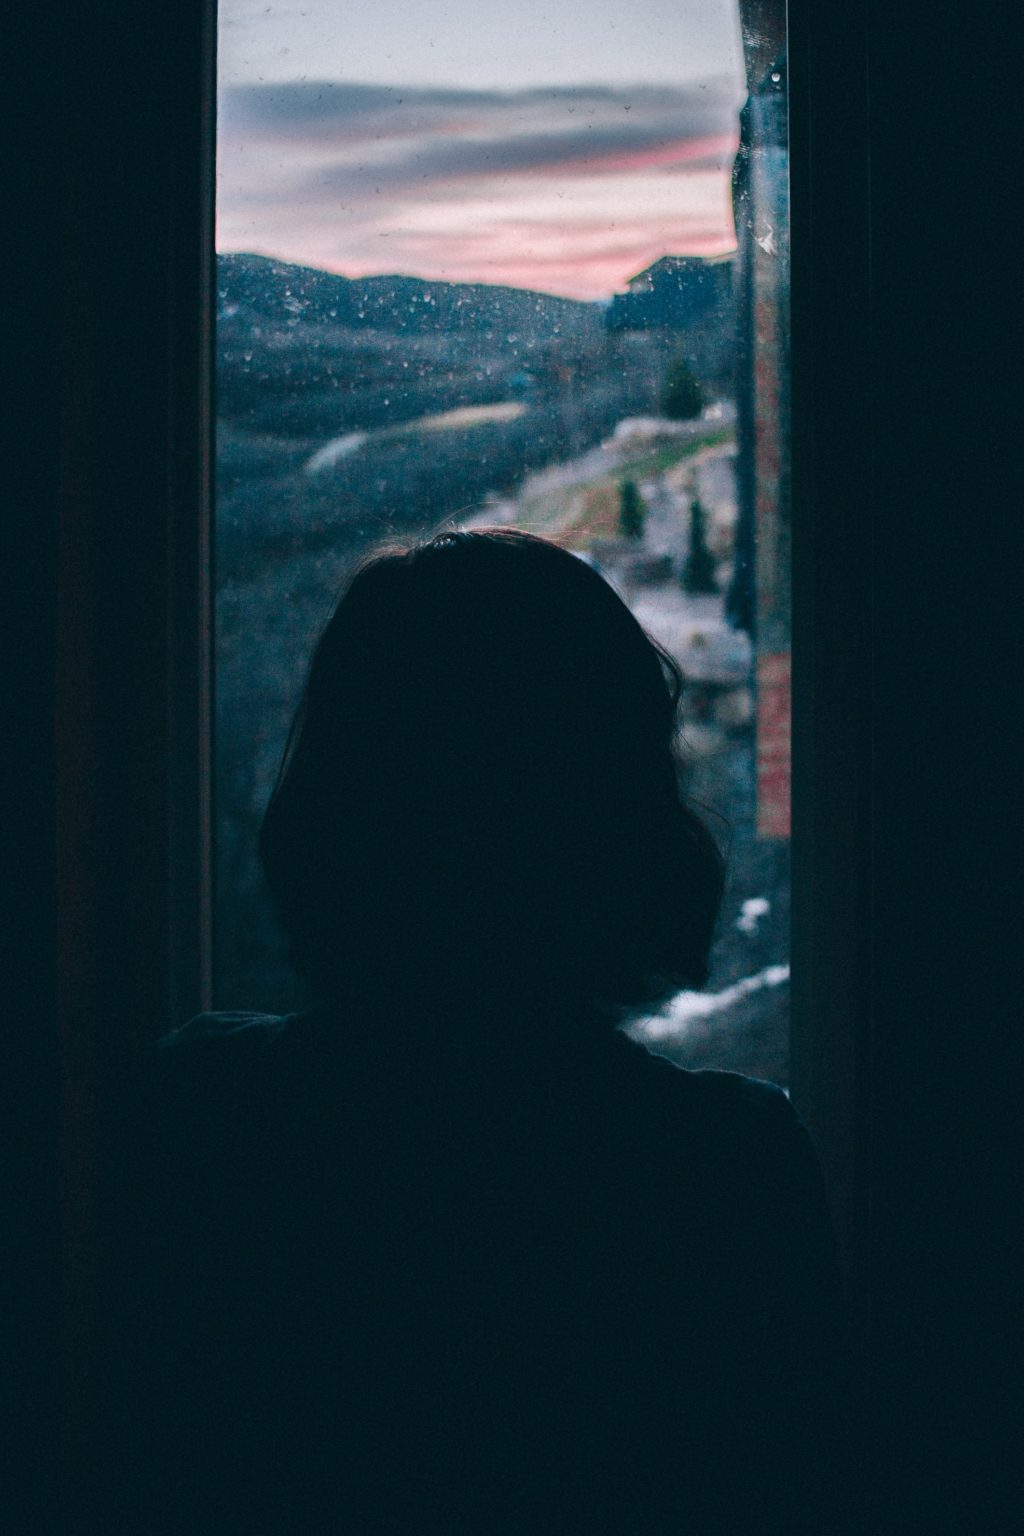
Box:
[216,0,745,300]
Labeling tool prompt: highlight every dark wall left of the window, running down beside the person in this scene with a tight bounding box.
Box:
[9,0,212,1531]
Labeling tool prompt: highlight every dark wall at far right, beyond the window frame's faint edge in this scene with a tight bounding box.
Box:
[869,5,1024,1530]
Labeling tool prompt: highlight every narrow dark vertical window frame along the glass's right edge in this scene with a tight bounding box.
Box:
[788,0,877,1332]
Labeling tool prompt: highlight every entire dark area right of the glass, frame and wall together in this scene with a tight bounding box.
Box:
[789,0,1022,1536]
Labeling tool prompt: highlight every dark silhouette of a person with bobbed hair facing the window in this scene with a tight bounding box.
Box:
[123,531,844,1536]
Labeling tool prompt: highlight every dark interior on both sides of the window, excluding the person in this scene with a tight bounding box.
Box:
[10,0,1019,1536]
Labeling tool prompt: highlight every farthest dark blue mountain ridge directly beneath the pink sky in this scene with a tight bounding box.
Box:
[216,253,603,346]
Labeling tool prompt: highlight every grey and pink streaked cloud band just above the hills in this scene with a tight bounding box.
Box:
[218,84,737,298]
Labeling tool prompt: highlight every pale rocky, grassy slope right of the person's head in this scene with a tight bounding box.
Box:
[464,420,789,1086]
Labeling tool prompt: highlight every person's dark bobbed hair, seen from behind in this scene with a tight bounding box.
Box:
[261,530,723,1015]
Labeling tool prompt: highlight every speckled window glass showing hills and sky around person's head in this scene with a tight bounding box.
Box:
[215,0,789,1083]
